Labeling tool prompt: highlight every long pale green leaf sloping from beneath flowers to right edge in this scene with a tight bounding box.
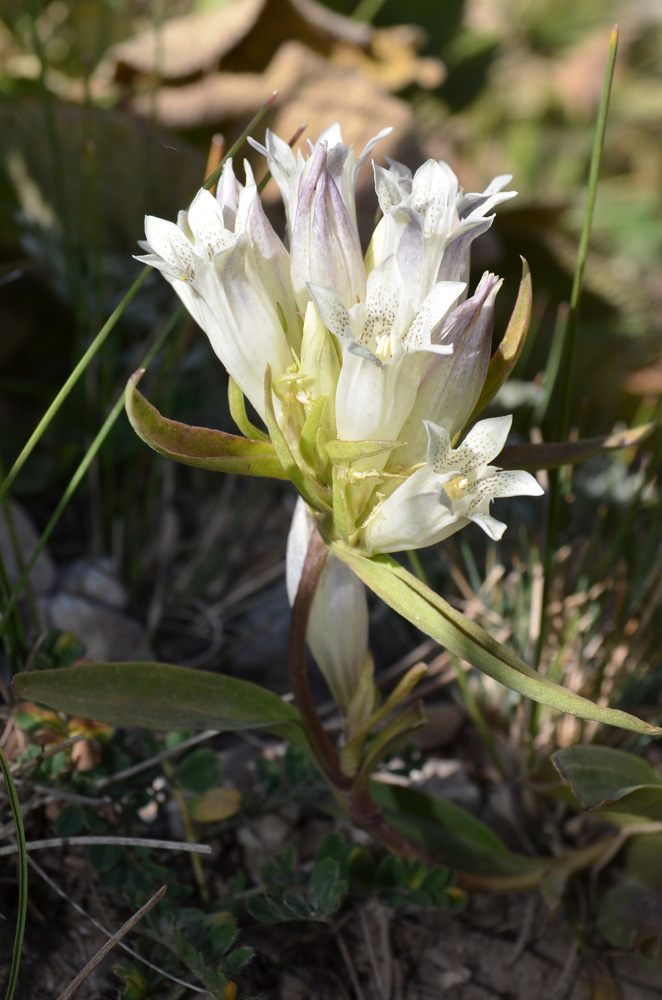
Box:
[332,542,662,736]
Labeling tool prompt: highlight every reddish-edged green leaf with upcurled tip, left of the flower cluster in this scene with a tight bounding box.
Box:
[124,370,287,479]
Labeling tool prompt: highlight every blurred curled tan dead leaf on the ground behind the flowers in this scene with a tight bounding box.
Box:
[93,0,443,128]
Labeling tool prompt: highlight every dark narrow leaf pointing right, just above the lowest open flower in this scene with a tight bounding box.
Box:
[494,423,655,472]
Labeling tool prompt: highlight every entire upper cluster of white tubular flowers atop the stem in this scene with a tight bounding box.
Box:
[139,125,541,560]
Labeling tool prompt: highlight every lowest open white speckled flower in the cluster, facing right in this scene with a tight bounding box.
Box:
[362,416,543,553]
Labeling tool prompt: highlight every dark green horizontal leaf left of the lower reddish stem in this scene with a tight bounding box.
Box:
[14,662,308,752]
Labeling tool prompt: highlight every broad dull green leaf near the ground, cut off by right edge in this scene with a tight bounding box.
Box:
[552,746,662,822]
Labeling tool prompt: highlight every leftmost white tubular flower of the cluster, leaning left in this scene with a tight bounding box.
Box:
[138,162,301,416]
